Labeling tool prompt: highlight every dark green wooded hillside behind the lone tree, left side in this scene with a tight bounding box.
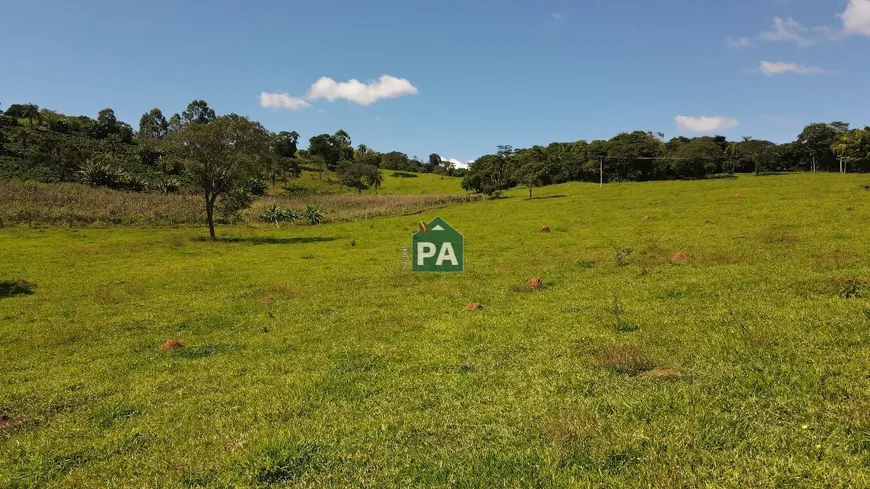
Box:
[0,100,461,192]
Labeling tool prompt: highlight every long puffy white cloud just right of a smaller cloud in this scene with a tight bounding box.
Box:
[306,75,418,105]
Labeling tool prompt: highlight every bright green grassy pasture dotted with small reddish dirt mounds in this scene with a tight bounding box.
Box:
[0,174,870,488]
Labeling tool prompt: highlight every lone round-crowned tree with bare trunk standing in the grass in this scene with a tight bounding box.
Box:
[167,114,270,239]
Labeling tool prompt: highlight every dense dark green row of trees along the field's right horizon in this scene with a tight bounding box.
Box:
[462,126,870,197]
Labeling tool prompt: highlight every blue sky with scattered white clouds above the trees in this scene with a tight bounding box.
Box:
[0,0,870,165]
